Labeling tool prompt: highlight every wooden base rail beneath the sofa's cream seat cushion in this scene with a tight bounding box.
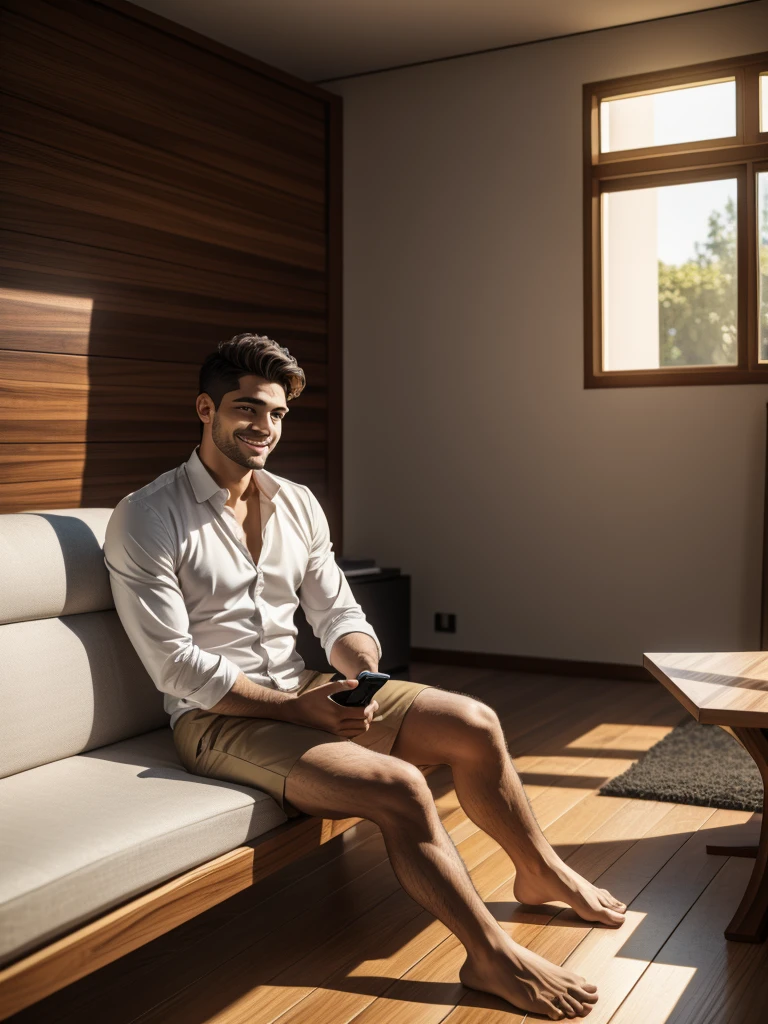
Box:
[0,811,364,1020]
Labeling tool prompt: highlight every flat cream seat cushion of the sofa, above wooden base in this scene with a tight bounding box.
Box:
[0,726,287,965]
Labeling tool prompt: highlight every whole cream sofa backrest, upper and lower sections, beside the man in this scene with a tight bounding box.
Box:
[0,509,169,778]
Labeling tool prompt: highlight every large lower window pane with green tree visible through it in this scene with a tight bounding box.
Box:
[602,178,741,370]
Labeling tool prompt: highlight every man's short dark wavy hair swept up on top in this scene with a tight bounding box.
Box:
[198,334,306,428]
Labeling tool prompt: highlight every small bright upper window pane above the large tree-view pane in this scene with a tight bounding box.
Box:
[600,79,736,153]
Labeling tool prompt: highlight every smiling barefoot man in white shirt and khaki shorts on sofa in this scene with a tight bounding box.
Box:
[104,335,626,1020]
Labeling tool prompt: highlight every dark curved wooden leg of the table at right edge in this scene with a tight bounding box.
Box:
[707,726,768,942]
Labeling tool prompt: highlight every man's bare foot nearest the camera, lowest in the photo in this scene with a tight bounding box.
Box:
[459,933,597,1021]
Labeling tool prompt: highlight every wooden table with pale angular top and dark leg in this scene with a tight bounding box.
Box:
[643,651,768,942]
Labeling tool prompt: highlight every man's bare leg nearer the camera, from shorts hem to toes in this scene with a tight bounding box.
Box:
[285,742,597,1020]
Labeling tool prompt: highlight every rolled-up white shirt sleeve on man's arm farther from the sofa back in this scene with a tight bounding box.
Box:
[299,487,381,665]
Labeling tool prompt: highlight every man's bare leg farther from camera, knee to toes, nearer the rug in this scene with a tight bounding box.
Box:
[391,687,627,925]
